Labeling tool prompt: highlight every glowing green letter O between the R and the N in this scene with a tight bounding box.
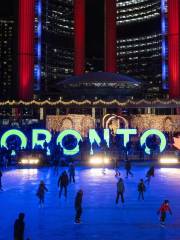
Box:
[56,129,82,156]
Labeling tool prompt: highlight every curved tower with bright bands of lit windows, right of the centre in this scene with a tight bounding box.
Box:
[117,0,168,97]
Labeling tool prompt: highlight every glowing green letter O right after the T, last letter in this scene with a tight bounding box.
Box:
[140,129,167,154]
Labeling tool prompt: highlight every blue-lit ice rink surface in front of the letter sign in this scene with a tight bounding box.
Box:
[0,166,180,240]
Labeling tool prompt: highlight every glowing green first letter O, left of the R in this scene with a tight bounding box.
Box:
[1,129,27,149]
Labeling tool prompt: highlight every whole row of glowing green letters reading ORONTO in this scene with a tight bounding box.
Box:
[0,129,169,156]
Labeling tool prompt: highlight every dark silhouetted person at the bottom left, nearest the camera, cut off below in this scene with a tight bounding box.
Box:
[14,213,25,240]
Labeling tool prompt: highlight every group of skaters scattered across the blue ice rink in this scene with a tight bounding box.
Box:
[0,161,172,240]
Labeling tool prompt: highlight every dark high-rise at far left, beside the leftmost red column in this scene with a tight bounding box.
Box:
[0,0,16,100]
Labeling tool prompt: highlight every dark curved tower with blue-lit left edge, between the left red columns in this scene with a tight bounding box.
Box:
[34,0,74,95]
